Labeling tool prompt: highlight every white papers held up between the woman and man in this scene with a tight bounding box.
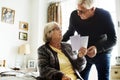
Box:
[70,35,88,51]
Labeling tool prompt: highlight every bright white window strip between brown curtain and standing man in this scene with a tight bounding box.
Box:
[61,0,77,34]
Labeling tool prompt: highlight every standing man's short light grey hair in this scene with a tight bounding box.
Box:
[77,0,94,9]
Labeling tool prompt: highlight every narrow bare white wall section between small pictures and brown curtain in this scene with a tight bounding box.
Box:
[29,0,48,59]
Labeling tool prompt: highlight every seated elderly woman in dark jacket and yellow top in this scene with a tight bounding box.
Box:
[38,22,87,80]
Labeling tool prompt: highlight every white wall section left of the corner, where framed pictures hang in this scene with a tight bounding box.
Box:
[0,0,30,67]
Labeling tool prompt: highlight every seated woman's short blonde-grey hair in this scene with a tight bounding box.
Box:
[43,22,59,43]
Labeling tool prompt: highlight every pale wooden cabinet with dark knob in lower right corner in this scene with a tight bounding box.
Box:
[110,65,120,80]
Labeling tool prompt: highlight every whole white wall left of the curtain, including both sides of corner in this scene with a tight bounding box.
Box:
[0,0,46,67]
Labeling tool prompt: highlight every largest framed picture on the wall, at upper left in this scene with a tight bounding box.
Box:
[1,7,15,24]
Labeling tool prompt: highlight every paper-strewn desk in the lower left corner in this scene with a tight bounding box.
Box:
[0,69,38,80]
